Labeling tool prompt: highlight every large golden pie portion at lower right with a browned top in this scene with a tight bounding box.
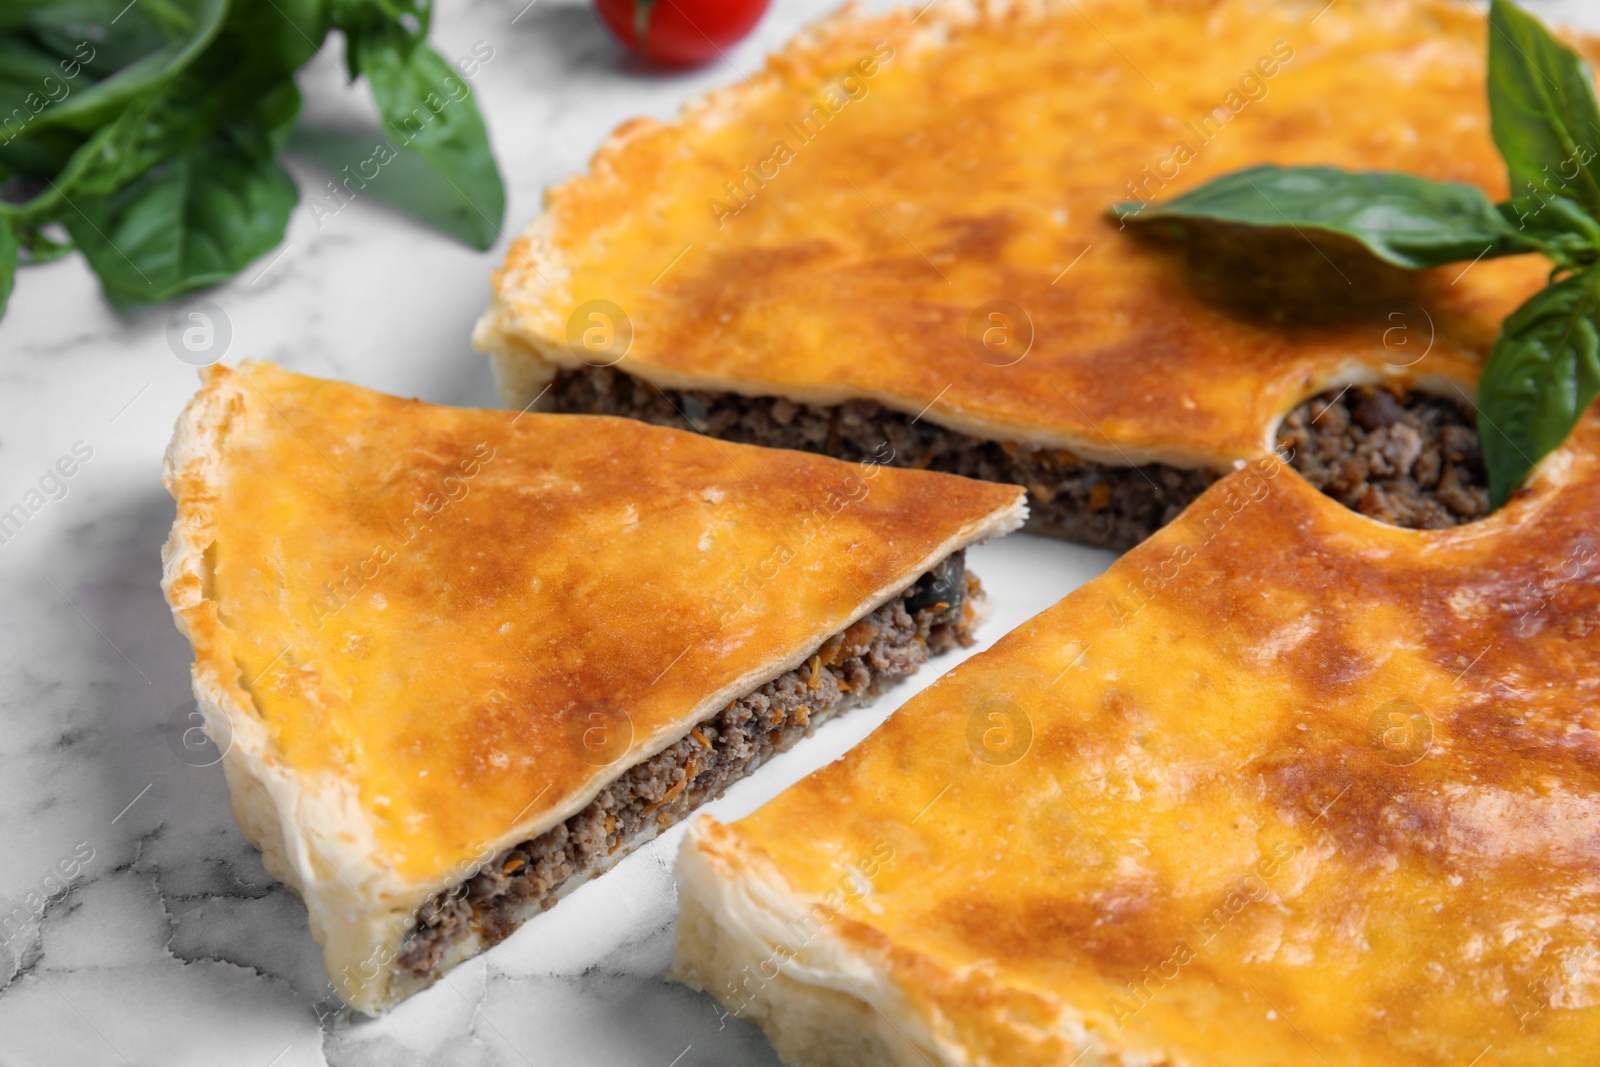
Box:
[674,408,1600,1067]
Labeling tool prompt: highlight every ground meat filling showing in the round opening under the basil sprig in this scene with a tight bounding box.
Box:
[1278,386,1490,530]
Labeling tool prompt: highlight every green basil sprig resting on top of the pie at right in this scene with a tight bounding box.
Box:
[1112,0,1600,507]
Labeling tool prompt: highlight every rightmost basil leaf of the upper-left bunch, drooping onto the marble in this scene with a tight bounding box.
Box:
[357,26,506,248]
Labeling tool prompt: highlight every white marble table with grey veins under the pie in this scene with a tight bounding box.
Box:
[0,0,1600,1067]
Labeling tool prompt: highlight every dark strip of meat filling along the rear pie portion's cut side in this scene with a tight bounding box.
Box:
[549,366,1218,549]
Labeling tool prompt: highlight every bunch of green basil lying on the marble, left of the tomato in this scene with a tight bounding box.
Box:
[0,0,506,314]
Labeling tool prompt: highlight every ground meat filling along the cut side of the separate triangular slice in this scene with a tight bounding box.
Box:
[398,552,982,977]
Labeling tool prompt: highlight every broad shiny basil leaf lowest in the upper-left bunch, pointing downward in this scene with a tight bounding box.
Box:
[62,125,298,310]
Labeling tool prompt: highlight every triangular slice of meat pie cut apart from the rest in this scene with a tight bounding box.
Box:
[163,363,1024,1013]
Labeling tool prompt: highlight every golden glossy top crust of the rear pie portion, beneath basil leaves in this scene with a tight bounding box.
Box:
[477,0,1592,467]
